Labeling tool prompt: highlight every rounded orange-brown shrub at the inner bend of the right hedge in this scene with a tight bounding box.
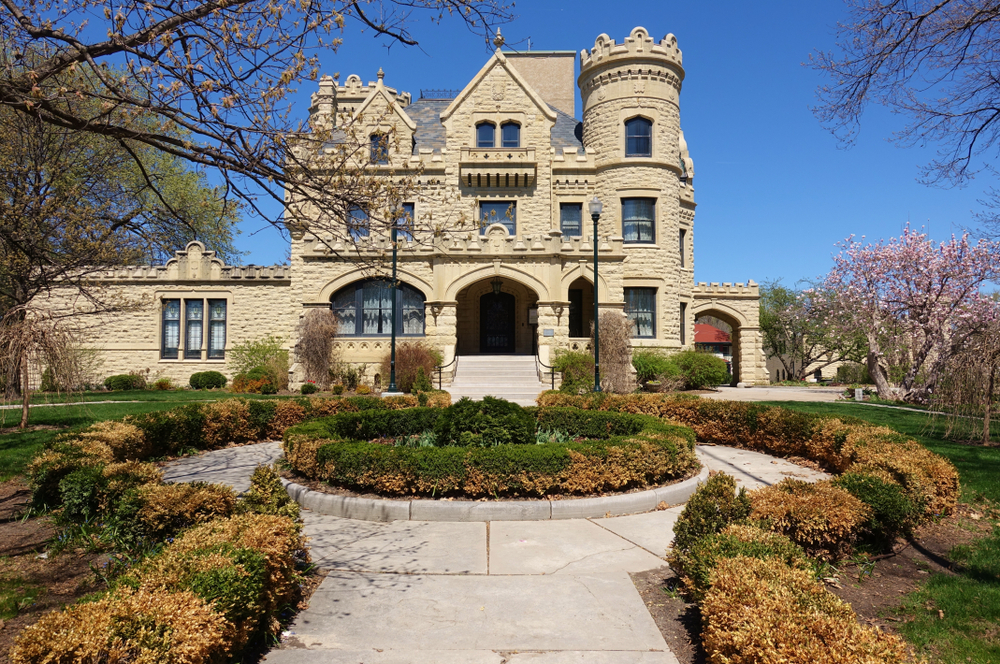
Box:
[750,479,871,560]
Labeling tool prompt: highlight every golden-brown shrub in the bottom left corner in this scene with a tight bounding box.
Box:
[10,587,227,664]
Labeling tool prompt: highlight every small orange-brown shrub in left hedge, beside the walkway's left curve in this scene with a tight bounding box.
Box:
[139,482,236,538]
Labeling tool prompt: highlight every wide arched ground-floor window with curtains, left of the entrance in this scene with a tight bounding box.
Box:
[330,279,424,337]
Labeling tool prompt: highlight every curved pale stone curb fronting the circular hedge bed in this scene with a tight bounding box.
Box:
[281,465,708,521]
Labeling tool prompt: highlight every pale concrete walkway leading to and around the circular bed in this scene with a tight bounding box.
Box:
[165,443,823,664]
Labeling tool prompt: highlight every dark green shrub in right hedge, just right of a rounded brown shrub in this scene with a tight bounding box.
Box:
[833,473,923,549]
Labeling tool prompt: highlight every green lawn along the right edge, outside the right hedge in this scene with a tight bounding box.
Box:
[756,402,1000,664]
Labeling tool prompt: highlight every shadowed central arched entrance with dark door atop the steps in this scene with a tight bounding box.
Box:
[455,275,538,355]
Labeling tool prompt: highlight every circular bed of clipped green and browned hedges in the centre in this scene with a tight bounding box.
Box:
[284,397,699,499]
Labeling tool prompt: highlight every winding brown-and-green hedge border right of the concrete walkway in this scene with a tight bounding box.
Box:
[539,392,959,664]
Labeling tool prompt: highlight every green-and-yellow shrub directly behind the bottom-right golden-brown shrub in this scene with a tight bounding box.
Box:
[669,524,811,602]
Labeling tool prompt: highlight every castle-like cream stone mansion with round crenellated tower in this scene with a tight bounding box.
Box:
[74,27,768,386]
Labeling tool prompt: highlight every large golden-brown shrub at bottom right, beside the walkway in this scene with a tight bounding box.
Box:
[701,557,909,664]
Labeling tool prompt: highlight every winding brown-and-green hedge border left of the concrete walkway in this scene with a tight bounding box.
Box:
[10,394,450,664]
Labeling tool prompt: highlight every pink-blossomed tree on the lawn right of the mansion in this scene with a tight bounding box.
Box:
[816,226,1000,403]
